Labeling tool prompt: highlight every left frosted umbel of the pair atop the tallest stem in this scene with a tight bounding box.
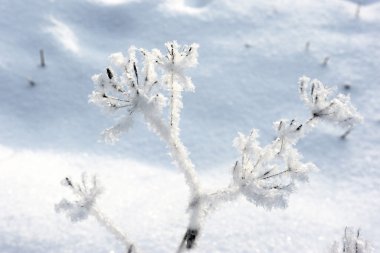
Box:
[89,47,163,114]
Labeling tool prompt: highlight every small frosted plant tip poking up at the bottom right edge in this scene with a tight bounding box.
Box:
[330,227,373,253]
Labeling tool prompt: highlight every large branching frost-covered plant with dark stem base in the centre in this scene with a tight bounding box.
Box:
[56,41,361,252]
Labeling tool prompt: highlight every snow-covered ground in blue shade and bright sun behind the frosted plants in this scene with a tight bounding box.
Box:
[0,0,380,253]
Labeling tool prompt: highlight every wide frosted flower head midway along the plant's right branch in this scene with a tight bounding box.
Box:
[233,124,316,209]
